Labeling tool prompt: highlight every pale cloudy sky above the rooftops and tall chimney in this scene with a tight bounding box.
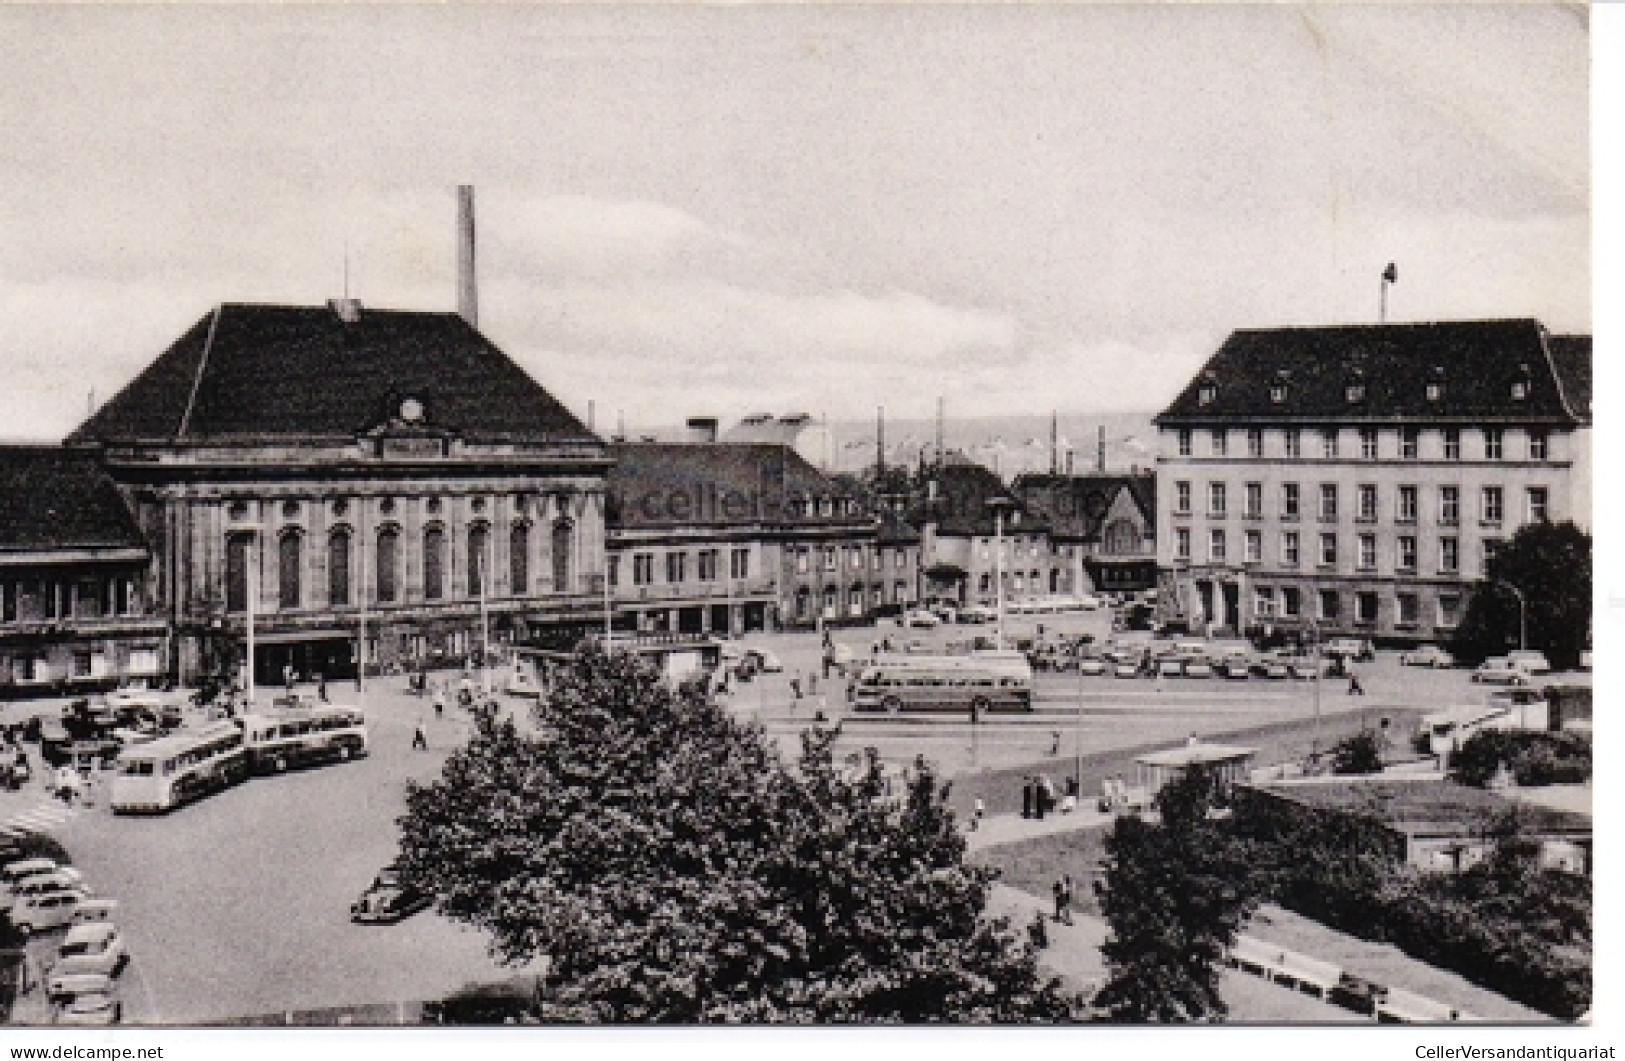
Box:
[0,5,1591,439]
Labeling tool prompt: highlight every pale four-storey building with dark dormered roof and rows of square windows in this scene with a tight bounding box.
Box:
[1155,320,1591,642]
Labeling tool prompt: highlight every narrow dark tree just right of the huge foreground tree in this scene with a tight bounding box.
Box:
[1094,769,1258,1024]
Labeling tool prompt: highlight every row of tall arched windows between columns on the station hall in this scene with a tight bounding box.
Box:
[226,520,575,613]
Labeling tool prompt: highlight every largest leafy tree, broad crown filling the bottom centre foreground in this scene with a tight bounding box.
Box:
[400,650,1073,1024]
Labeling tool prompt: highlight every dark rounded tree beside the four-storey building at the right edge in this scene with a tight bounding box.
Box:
[1453,523,1591,669]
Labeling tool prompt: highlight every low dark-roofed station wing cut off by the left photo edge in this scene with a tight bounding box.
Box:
[0,447,169,697]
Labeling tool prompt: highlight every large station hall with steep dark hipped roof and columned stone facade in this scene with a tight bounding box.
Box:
[68,301,609,681]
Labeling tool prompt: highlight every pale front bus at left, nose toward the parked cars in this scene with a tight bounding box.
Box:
[109,721,249,814]
